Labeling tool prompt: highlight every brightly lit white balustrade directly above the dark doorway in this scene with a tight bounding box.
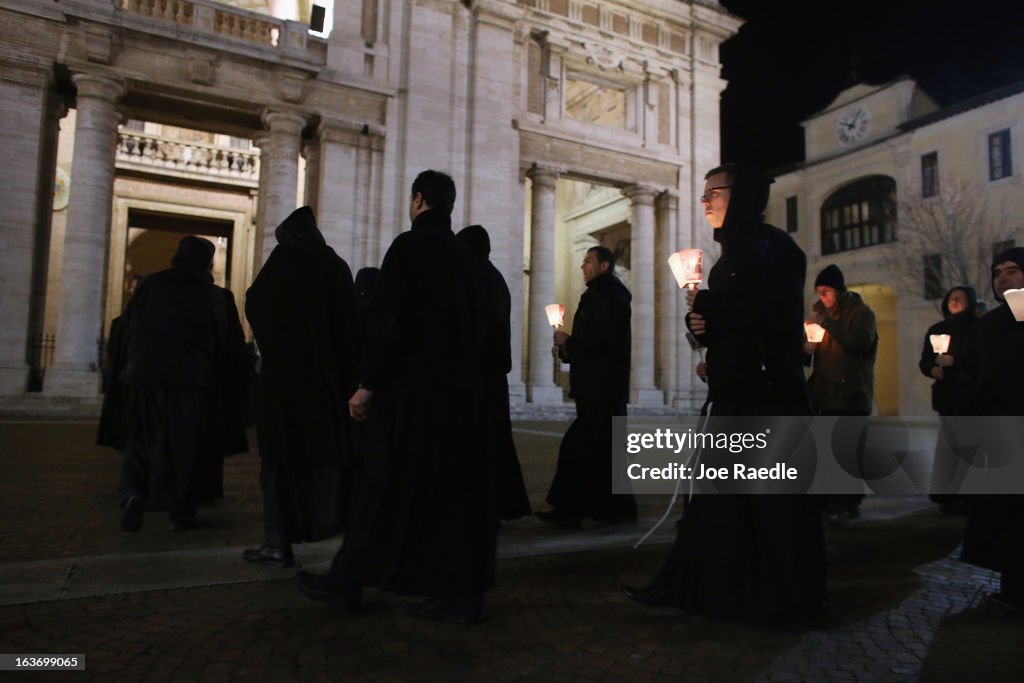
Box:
[117,130,259,187]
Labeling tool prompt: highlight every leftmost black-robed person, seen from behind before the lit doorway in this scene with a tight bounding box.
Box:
[120,236,248,531]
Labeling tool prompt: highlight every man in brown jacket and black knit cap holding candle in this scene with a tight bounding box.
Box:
[805,264,879,524]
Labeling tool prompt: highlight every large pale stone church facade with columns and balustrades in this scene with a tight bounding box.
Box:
[0,0,739,411]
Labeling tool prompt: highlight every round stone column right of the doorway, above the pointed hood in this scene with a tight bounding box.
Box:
[256,112,306,269]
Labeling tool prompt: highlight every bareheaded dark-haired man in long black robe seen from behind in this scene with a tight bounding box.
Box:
[299,171,498,623]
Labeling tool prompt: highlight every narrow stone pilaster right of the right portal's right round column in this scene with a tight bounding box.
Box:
[654,191,686,405]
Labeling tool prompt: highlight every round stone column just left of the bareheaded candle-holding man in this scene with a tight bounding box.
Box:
[526,166,567,404]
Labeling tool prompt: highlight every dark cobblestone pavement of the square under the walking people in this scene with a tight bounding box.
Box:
[0,421,1024,681]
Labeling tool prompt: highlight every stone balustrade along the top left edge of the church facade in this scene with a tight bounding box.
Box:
[115,0,309,56]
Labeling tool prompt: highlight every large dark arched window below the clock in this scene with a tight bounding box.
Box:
[821,175,896,255]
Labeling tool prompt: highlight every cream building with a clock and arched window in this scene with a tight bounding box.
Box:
[767,78,1024,416]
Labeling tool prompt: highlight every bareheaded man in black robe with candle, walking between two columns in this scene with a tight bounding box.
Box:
[537,247,637,528]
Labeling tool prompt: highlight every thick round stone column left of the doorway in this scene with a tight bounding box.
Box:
[43,74,124,396]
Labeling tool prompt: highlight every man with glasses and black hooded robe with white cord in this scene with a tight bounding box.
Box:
[624,164,825,622]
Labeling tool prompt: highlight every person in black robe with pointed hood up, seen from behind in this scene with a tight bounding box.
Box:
[244,207,356,566]
